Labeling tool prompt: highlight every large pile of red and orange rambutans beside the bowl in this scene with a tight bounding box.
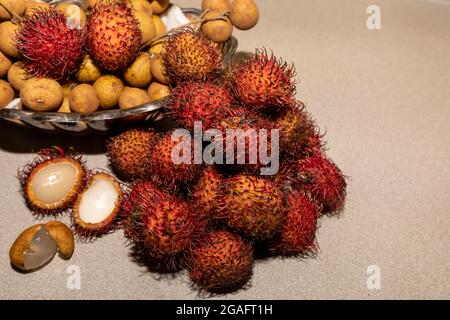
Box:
[108,46,346,293]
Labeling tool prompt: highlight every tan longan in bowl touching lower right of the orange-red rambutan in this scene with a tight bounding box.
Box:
[123,52,152,88]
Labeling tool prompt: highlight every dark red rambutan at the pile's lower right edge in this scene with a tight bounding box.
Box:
[269,191,319,256]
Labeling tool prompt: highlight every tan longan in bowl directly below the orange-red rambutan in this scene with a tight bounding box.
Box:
[94,75,124,110]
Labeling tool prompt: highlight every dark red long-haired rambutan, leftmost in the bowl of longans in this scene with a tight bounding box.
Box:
[16,9,86,80]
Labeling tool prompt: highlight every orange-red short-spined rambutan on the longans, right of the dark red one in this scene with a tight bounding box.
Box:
[87,0,142,71]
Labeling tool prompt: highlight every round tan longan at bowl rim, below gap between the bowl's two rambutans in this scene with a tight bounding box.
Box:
[69,83,100,114]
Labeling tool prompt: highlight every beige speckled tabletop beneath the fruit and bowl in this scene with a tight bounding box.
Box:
[0,0,450,299]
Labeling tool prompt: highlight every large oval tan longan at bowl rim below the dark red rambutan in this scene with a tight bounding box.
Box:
[20,78,64,112]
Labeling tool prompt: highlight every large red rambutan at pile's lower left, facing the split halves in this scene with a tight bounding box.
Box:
[122,182,201,262]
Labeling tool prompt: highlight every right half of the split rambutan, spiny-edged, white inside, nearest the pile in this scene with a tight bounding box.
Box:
[71,170,123,241]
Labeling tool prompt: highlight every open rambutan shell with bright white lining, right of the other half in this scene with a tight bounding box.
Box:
[72,173,122,238]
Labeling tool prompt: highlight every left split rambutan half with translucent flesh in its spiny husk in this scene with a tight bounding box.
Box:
[17,147,86,216]
